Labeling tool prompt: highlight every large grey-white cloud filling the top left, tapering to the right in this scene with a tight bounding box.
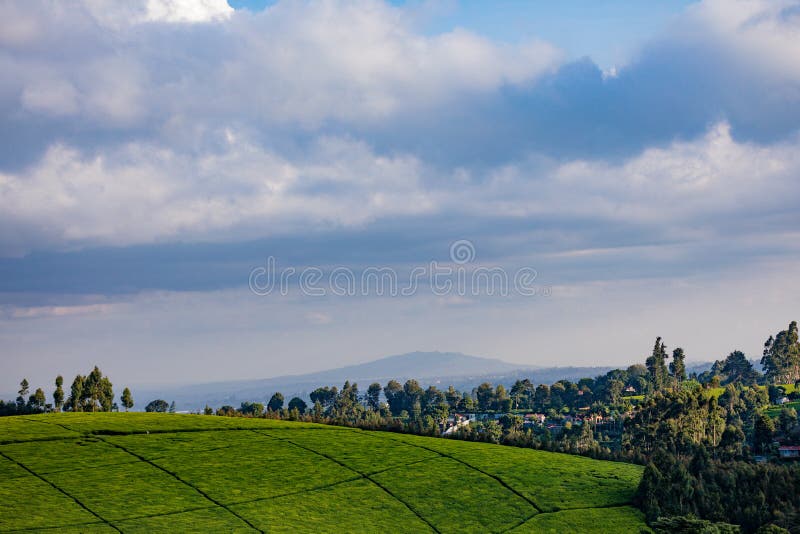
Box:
[0,0,560,128]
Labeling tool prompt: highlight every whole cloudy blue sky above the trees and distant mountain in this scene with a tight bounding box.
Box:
[0,0,800,392]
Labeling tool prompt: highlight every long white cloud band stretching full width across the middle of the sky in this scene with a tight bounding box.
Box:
[0,123,800,254]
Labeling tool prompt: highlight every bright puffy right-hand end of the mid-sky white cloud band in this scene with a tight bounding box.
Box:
[555,122,800,224]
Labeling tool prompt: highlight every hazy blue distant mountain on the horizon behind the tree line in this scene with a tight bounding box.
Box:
[132,352,611,410]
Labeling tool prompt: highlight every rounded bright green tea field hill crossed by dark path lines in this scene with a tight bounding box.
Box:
[0,413,645,533]
